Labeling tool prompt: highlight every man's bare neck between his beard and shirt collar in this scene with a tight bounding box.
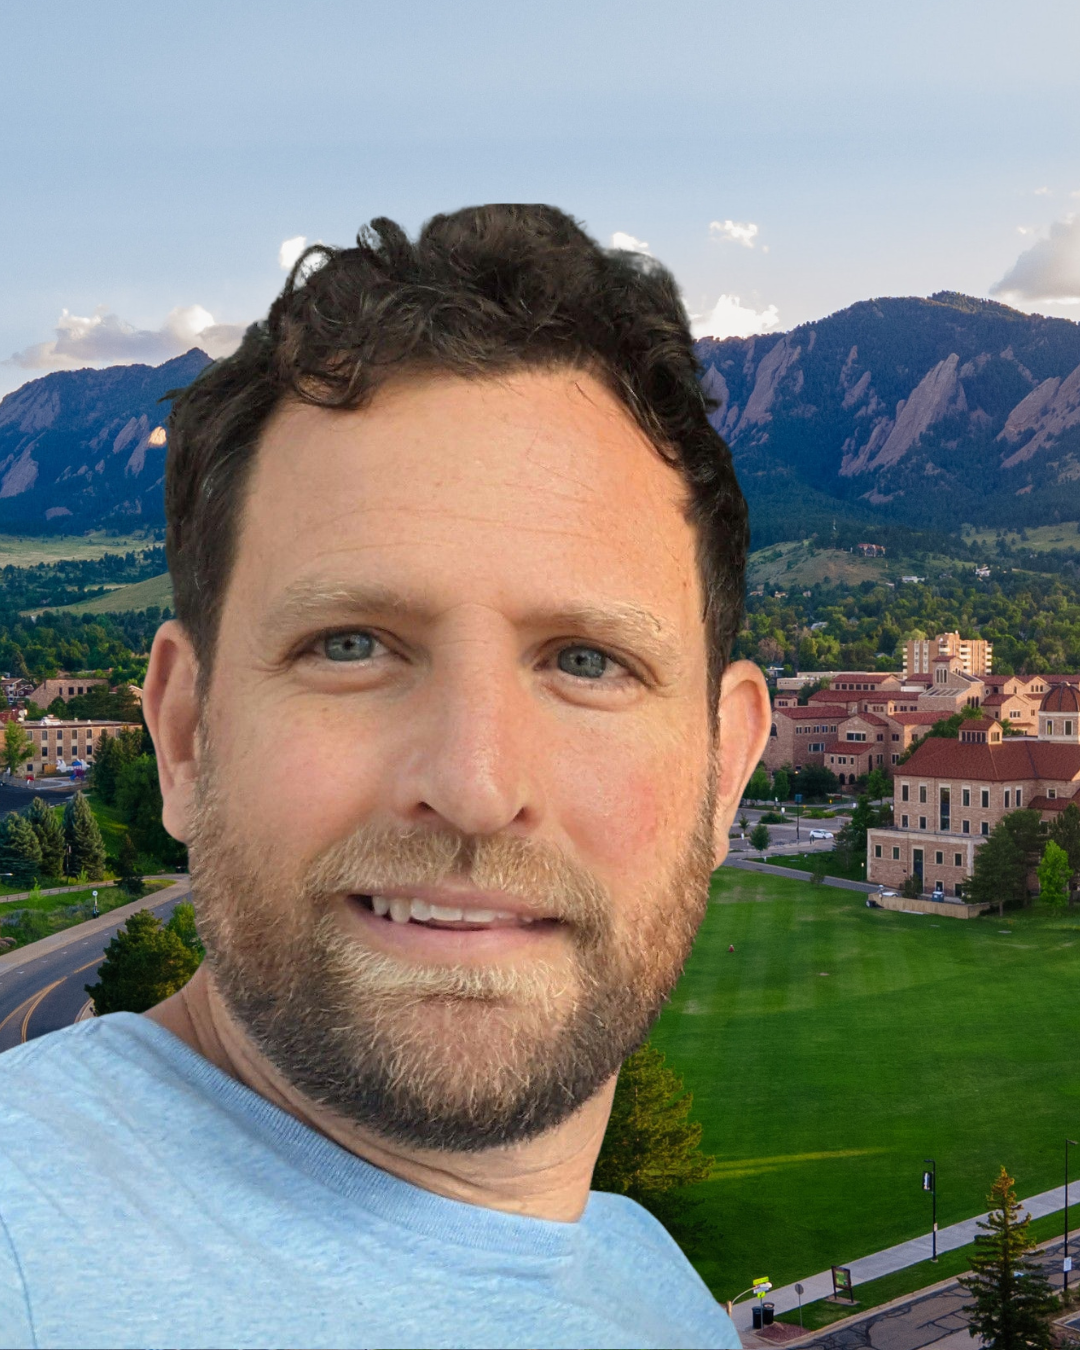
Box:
[144,965,616,1223]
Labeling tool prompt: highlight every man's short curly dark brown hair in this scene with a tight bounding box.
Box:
[165,205,748,713]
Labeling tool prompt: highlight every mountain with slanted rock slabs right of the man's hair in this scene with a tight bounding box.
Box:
[698,292,1080,544]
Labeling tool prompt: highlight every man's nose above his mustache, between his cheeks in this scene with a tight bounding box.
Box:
[392,645,541,834]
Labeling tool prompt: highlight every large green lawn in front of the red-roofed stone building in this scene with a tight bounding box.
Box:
[652,869,1080,1297]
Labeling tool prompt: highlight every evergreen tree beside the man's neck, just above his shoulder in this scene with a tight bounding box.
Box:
[593,1044,713,1207]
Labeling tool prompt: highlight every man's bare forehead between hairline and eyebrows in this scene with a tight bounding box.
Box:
[227,370,699,637]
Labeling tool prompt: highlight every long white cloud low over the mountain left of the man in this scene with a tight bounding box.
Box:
[4,305,246,370]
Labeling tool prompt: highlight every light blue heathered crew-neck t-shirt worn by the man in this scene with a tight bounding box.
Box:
[0,1013,738,1350]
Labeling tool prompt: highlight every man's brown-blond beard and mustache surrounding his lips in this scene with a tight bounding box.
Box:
[189,744,716,1153]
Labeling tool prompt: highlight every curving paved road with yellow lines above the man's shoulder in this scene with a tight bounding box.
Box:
[0,876,190,1050]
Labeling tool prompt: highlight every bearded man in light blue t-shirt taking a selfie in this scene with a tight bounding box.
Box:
[0,207,768,1346]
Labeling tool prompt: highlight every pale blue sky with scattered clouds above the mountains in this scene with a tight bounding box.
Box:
[0,0,1080,393]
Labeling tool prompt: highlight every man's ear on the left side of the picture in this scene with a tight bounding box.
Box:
[143,620,198,844]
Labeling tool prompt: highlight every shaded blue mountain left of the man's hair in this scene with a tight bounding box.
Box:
[0,348,209,533]
